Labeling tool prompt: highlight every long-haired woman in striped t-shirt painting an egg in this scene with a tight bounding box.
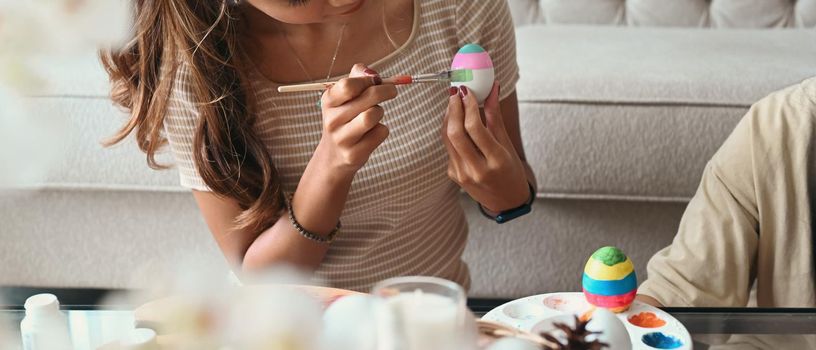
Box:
[103,0,535,291]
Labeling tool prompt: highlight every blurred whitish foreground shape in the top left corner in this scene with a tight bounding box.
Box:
[0,0,132,188]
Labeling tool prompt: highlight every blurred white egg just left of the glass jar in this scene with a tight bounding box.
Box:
[321,295,381,350]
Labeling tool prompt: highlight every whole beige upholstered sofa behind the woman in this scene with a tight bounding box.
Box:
[0,0,816,297]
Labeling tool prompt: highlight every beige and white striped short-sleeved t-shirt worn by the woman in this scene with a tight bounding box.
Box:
[165,0,518,292]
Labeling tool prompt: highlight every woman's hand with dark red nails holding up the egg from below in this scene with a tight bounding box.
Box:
[442,83,530,213]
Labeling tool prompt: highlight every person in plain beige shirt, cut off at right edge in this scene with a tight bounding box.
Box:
[639,78,816,307]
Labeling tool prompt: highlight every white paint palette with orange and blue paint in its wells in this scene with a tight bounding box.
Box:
[482,293,692,350]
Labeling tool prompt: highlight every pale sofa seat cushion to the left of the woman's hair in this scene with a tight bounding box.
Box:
[15,54,187,192]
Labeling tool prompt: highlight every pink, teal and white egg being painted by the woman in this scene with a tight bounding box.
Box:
[451,44,495,104]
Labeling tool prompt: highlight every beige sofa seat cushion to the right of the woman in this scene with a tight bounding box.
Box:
[517,26,816,201]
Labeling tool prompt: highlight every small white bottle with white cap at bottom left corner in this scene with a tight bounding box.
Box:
[20,294,73,350]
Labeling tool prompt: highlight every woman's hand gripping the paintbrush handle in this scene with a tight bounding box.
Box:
[315,64,397,176]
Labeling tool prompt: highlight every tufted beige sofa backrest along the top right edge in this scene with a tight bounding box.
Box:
[508,0,816,28]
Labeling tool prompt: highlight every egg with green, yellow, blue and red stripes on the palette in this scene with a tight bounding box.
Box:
[582,247,637,312]
